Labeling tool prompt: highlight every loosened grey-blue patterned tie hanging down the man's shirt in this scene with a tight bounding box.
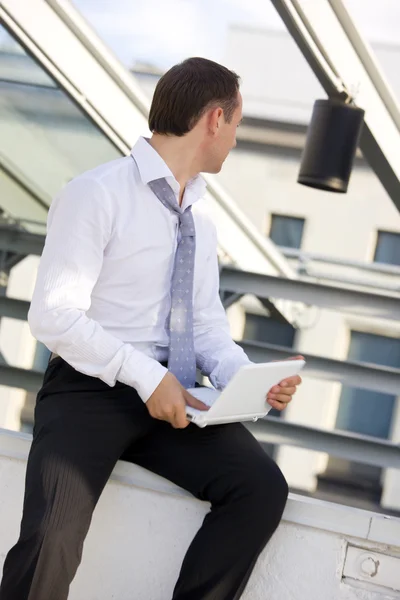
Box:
[149,178,196,388]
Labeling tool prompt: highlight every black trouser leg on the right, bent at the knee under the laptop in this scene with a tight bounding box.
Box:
[125,424,288,600]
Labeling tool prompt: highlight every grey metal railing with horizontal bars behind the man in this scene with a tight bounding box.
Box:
[0,258,400,469]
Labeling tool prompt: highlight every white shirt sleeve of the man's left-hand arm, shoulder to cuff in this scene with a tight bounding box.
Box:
[28,178,167,402]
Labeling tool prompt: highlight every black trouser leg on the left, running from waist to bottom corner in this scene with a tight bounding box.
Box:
[0,359,151,600]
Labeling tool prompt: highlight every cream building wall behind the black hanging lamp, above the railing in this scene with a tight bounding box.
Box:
[219,149,400,261]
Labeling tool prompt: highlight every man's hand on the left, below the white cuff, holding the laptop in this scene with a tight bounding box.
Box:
[146,372,208,429]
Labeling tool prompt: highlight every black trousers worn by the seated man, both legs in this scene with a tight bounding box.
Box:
[0,358,288,600]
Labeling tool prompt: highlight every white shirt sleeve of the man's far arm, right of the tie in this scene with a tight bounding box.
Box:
[193,228,251,390]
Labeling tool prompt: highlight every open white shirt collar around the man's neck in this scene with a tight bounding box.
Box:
[131,137,207,208]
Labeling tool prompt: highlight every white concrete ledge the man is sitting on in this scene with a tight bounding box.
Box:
[0,430,400,600]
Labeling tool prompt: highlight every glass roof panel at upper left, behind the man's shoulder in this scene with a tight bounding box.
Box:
[0,26,120,227]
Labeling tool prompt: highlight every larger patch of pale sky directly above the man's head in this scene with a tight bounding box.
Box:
[74,0,280,68]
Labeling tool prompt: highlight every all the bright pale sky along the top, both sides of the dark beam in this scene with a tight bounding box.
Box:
[73,0,400,69]
